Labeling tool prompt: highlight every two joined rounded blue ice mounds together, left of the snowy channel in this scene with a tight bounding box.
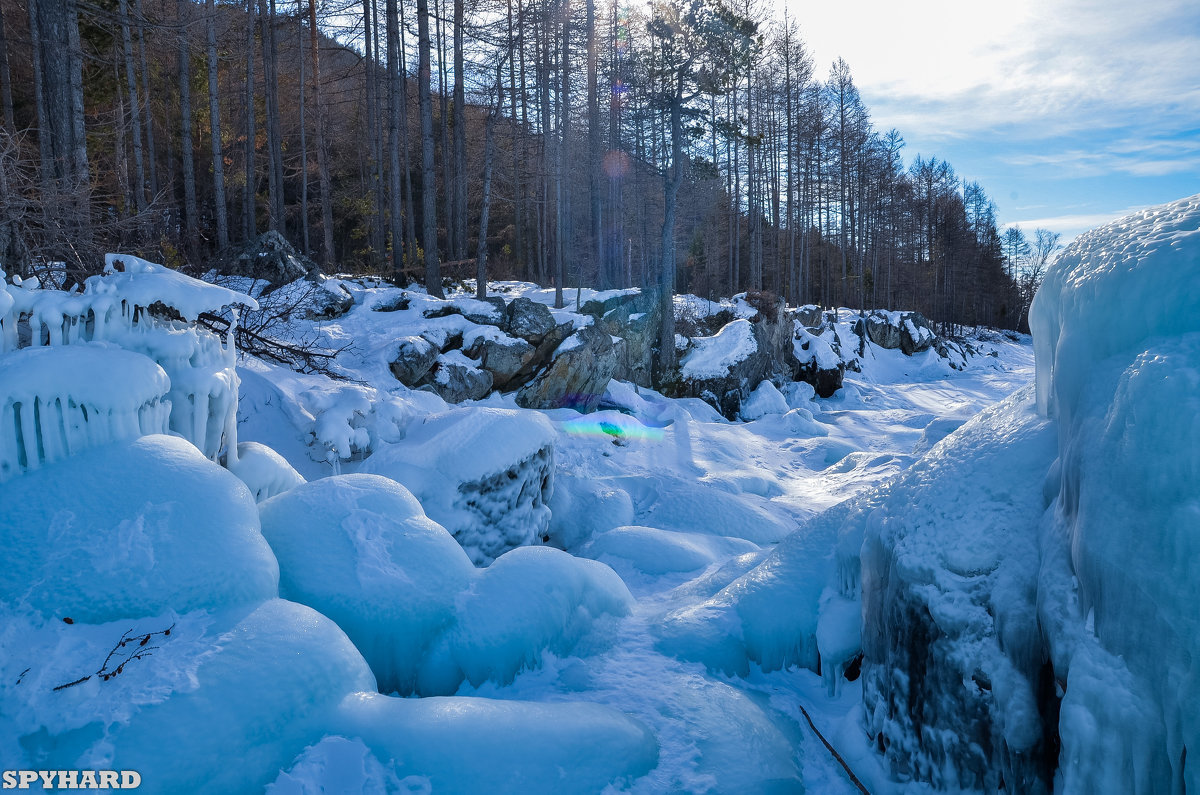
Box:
[262,474,632,695]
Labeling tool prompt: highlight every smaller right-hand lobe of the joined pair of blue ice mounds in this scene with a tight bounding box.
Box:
[419,546,634,695]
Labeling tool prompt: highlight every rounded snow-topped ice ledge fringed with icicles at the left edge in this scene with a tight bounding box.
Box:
[0,342,170,483]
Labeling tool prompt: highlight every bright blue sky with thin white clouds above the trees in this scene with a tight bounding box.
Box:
[774,0,1200,243]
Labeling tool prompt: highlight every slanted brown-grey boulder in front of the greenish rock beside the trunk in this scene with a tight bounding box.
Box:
[514,324,619,412]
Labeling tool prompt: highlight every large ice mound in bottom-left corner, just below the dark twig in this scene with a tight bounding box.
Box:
[9,599,374,794]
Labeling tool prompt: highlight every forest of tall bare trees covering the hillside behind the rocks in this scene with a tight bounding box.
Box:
[0,0,1044,338]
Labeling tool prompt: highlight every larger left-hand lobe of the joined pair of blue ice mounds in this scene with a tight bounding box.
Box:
[260,474,475,695]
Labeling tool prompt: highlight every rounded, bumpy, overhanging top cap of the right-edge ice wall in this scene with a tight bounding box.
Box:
[1030,195,1200,416]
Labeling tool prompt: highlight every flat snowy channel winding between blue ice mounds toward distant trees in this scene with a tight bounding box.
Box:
[461,345,1033,794]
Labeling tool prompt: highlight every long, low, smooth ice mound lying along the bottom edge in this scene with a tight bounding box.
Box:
[332,693,658,794]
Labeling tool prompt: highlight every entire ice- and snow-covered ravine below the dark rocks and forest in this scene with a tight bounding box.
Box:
[0,197,1200,794]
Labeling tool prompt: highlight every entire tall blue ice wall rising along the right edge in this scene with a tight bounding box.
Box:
[1030,196,1200,794]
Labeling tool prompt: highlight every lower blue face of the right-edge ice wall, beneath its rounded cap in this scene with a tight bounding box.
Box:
[1039,333,1200,794]
